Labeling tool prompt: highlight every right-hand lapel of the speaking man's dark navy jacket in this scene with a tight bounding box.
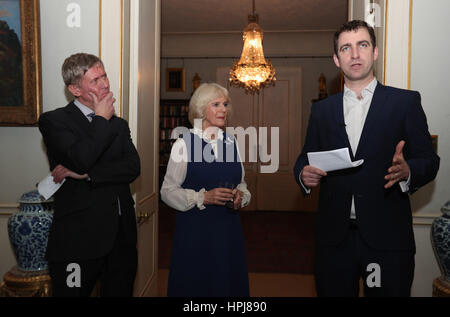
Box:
[355,83,387,159]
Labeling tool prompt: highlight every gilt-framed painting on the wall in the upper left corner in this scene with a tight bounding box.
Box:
[0,0,42,126]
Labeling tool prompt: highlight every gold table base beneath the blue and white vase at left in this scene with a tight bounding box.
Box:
[0,266,51,297]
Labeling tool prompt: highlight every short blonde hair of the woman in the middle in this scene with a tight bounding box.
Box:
[189,83,232,126]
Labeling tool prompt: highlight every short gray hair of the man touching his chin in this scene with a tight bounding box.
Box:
[61,53,104,86]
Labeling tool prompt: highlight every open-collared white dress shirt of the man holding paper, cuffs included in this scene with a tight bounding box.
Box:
[299,78,411,219]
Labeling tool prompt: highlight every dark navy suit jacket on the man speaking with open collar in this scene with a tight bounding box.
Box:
[294,83,439,250]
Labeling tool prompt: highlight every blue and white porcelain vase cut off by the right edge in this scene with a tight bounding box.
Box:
[431,200,450,282]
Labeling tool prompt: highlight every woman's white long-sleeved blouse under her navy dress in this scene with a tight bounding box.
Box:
[161,128,251,211]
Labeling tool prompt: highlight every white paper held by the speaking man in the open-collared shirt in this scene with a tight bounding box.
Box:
[308,147,364,172]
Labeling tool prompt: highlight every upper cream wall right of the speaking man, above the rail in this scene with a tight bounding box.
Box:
[411,0,450,215]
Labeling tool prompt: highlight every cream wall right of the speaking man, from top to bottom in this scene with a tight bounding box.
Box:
[412,0,450,296]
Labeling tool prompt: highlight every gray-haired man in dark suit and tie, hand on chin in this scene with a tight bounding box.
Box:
[39,53,140,296]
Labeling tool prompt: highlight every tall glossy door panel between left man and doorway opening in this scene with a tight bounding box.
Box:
[125,0,160,297]
